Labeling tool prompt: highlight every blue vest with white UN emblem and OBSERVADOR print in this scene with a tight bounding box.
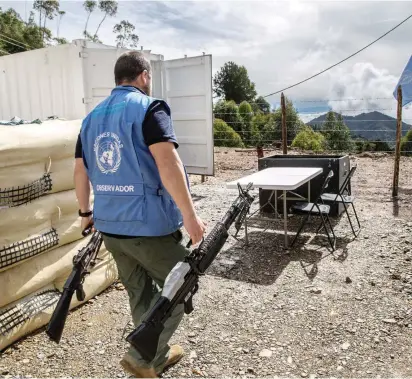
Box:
[80,86,188,236]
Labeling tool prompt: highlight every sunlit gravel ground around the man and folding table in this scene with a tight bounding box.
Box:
[0,149,412,378]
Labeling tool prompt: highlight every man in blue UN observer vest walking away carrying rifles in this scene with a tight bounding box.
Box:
[74,51,205,378]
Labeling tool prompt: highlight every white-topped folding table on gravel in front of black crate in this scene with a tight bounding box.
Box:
[226,167,323,248]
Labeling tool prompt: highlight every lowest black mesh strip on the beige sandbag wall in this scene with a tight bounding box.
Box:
[0,290,60,335]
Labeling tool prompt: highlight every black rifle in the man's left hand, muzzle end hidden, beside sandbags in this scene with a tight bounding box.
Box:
[46,227,103,343]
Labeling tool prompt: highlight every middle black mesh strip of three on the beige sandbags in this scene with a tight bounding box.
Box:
[0,228,59,269]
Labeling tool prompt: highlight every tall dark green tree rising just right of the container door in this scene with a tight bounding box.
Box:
[213,62,257,104]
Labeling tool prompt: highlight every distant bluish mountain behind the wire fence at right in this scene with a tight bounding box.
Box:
[307,112,412,147]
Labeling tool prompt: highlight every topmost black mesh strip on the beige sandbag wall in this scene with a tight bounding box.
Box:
[0,173,52,207]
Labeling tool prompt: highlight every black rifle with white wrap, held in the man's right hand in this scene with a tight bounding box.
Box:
[126,183,254,362]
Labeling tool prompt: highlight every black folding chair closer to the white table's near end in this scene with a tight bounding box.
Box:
[290,170,336,251]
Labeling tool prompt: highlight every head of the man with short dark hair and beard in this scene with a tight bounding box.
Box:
[114,51,152,96]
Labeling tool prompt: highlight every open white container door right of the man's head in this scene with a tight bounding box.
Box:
[159,55,214,175]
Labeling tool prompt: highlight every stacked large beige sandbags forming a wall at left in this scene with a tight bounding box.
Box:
[0,120,118,350]
